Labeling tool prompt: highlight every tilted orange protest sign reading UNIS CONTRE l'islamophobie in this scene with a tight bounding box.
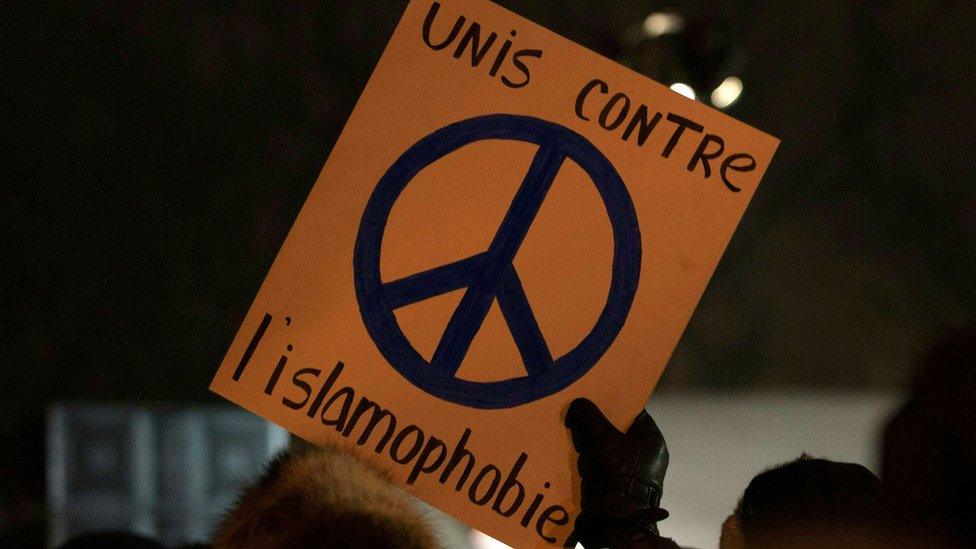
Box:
[211,0,777,547]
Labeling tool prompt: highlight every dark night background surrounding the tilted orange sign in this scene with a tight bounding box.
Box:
[0,0,976,540]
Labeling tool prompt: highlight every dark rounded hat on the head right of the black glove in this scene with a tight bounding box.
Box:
[735,455,881,545]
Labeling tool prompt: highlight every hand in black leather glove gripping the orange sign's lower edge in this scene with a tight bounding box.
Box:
[566,398,670,549]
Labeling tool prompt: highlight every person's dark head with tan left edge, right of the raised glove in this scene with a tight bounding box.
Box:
[720,456,881,549]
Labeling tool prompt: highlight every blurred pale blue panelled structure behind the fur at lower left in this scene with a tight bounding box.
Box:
[47,404,288,546]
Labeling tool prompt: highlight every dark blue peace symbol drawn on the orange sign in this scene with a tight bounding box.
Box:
[353,114,641,408]
